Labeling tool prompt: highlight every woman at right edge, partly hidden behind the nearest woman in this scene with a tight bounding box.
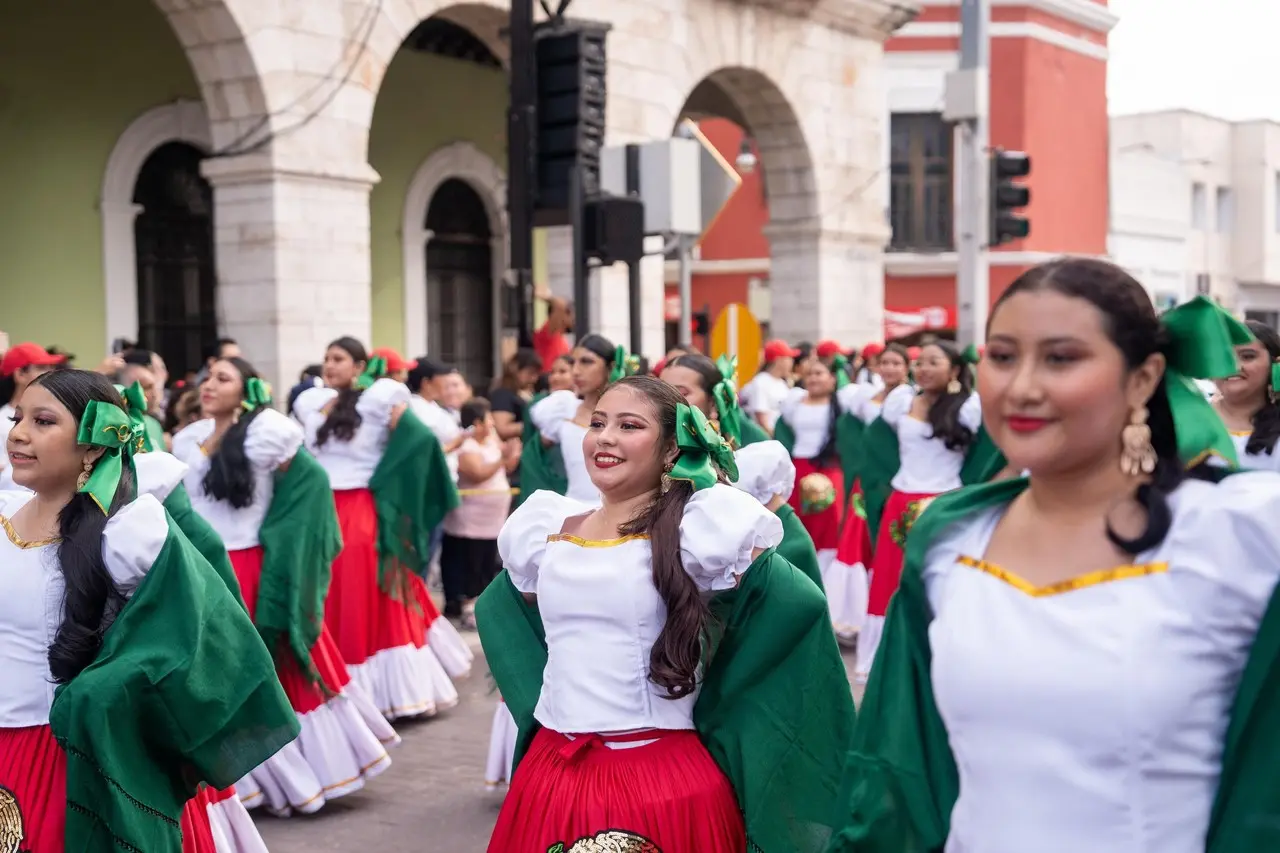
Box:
[1213,320,1280,471]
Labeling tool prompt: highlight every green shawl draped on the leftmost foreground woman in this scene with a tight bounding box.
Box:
[50,520,300,853]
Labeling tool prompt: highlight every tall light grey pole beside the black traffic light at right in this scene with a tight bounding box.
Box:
[955,0,991,346]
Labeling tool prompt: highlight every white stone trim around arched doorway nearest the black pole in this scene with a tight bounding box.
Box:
[401,141,507,366]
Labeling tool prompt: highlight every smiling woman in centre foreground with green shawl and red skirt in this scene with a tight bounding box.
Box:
[476,377,852,853]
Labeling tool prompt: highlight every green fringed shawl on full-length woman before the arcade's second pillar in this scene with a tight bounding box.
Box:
[369,409,461,594]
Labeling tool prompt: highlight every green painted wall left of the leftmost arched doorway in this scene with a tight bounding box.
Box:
[0,0,200,358]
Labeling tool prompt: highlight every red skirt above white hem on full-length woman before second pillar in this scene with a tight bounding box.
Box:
[324,489,426,666]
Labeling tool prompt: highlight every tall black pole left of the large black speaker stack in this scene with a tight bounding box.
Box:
[507,0,538,347]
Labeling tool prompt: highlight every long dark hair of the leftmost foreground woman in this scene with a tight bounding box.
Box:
[31,370,136,684]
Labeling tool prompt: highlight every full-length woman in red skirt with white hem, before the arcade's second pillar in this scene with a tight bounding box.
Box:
[293,338,471,720]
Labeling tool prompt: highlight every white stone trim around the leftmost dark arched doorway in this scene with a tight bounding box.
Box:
[99,100,212,343]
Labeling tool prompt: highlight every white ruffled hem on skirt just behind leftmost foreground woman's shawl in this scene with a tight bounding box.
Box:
[236,680,399,817]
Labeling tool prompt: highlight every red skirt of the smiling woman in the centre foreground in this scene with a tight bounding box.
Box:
[489,729,746,853]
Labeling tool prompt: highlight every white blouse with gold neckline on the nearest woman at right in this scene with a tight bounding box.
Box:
[924,473,1280,853]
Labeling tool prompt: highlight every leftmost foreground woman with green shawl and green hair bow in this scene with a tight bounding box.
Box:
[0,370,298,853]
